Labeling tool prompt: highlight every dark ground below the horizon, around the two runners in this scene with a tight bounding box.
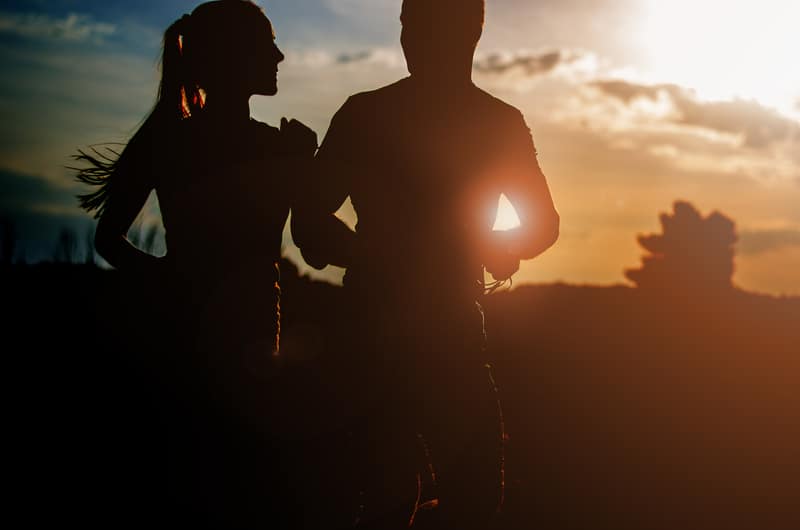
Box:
[0,265,800,530]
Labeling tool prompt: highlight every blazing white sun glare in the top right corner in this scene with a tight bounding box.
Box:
[637,0,800,113]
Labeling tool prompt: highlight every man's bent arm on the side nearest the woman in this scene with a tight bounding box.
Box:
[291,100,356,269]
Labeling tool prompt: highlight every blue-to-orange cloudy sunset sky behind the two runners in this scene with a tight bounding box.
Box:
[0,0,800,295]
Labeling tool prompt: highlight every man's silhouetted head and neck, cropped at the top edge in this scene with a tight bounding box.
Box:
[400,0,485,79]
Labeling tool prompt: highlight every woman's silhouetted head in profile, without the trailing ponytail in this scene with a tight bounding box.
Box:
[160,0,284,115]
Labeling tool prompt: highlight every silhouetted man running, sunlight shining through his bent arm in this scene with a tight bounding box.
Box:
[292,0,559,528]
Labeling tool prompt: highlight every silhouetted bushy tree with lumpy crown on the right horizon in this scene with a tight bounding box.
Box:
[625,201,737,291]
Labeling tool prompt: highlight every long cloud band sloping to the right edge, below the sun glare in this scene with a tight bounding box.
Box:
[589,80,800,149]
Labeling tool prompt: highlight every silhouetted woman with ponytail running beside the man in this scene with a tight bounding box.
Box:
[72,0,316,528]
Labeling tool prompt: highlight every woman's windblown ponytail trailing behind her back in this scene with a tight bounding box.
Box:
[69,15,204,219]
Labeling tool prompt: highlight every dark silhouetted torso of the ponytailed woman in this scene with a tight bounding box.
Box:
[155,118,292,343]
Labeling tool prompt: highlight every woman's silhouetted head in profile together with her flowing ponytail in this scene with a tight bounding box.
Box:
[74,0,284,216]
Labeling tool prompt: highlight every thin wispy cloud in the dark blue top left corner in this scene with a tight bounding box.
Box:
[0,13,117,42]
